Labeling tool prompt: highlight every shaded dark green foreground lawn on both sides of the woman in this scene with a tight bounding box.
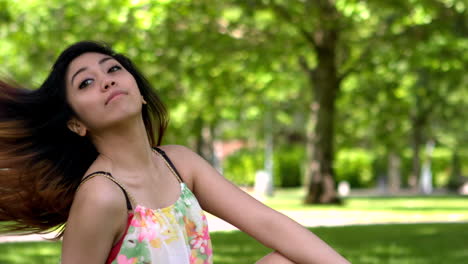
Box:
[0,223,468,264]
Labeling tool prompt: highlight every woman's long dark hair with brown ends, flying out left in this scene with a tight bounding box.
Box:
[0,41,168,238]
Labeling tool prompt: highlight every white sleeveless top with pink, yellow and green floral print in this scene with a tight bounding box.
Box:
[112,182,213,264]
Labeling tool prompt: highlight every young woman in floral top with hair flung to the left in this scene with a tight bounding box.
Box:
[0,42,348,264]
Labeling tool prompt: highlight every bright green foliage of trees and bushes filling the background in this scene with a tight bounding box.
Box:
[0,0,468,191]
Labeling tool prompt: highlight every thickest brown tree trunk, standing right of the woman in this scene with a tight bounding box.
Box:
[305,0,340,204]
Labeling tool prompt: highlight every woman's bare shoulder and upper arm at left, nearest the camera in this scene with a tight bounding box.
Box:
[61,177,127,264]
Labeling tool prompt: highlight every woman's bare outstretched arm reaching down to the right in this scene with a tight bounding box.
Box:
[165,146,349,264]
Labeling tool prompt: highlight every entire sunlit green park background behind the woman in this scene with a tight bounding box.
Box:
[0,0,468,264]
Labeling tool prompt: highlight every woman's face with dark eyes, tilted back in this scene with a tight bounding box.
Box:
[65,52,142,132]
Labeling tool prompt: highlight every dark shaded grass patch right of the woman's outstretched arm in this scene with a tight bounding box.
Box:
[312,223,468,264]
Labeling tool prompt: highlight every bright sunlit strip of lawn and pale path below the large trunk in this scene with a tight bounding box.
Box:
[263,188,468,224]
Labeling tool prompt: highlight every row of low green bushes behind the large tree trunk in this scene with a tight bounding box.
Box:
[223,145,468,188]
